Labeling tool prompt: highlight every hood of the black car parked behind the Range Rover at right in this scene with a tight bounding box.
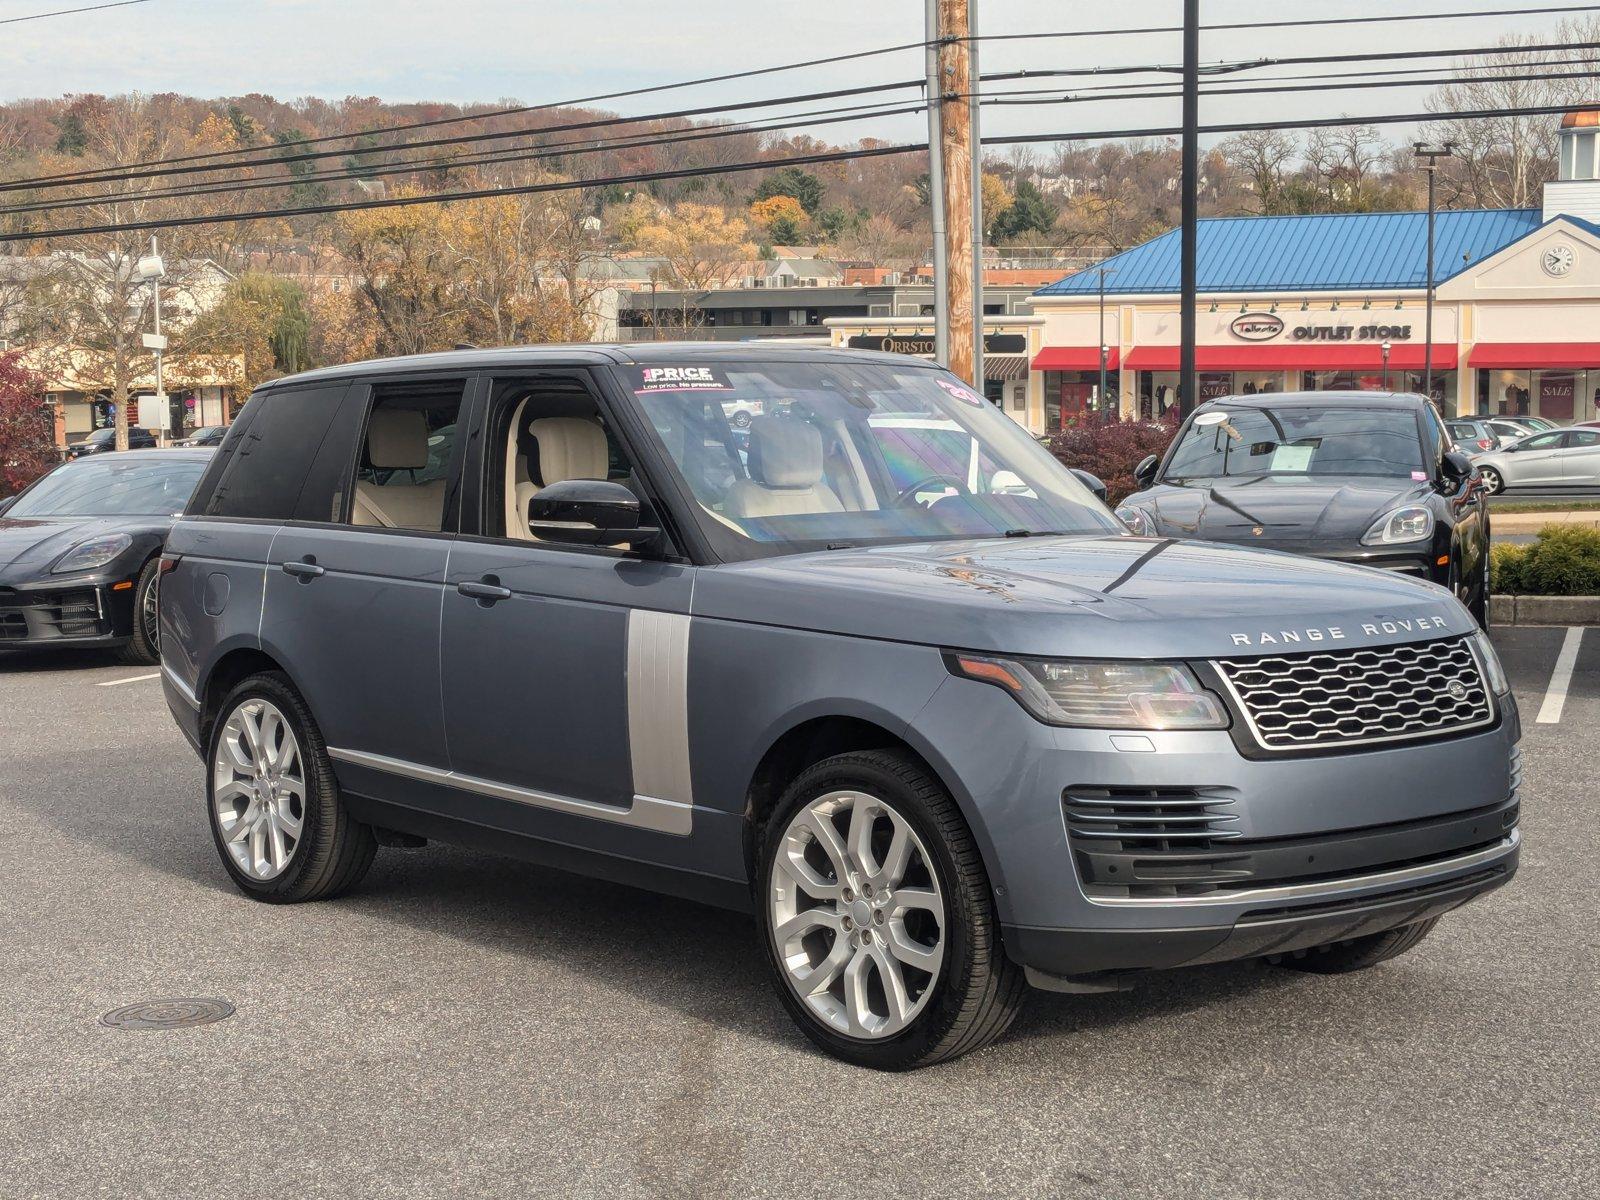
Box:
[1123,475,1430,546]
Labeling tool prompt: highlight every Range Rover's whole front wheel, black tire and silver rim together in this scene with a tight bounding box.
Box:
[757,750,1024,1070]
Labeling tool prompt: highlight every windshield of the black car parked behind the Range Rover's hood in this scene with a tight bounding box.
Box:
[1162,405,1427,483]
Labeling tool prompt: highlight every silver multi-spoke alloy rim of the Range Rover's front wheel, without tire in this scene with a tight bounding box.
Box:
[768,790,947,1040]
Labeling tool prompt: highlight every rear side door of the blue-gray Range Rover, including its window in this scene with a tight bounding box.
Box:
[261,376,470,790]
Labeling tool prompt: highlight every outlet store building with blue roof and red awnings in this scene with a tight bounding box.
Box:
[1029,112,1600,432]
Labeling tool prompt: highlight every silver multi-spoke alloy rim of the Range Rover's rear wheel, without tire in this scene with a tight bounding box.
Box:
[211,698,306,880]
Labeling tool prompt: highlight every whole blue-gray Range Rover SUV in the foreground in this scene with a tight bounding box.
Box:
[160,346,1520,1069]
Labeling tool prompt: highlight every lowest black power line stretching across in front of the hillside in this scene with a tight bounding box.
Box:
[0,104,1593,242]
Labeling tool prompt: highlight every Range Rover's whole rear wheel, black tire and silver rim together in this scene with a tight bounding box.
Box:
[206,672,378,904]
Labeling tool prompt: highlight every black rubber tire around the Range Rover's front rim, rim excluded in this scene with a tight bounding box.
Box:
[755,750,1026,1070]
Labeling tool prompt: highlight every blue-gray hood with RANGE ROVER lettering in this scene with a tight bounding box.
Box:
[694,536,1477,658]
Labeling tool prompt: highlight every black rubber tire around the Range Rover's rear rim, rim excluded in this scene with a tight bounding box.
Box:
[205,672,378,904]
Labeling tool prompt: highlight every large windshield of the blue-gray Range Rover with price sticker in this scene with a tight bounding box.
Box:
[621,360,1122,557]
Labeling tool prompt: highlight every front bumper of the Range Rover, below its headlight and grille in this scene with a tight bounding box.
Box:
[917,680,1522,976]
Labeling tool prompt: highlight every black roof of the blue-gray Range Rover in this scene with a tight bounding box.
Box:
[262,341,934,387]
